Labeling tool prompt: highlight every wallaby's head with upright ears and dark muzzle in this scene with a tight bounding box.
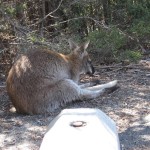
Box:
[69,40,95,75]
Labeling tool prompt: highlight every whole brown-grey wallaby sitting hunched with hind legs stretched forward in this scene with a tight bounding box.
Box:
[6,40,117,114]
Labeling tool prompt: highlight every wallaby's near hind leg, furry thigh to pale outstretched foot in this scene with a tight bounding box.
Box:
[45,79,117,111]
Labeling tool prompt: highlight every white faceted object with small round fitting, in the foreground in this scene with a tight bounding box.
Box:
[40,108,120,150]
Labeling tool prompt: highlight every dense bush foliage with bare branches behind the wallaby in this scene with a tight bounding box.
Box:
[0,0,150,65]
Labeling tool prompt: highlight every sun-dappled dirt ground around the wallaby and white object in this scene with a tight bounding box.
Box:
[0,61,150,150]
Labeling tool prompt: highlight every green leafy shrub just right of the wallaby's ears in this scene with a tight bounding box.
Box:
[88,27,127,60]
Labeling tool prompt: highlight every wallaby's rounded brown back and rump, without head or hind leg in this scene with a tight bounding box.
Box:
[7,49,70,114]
